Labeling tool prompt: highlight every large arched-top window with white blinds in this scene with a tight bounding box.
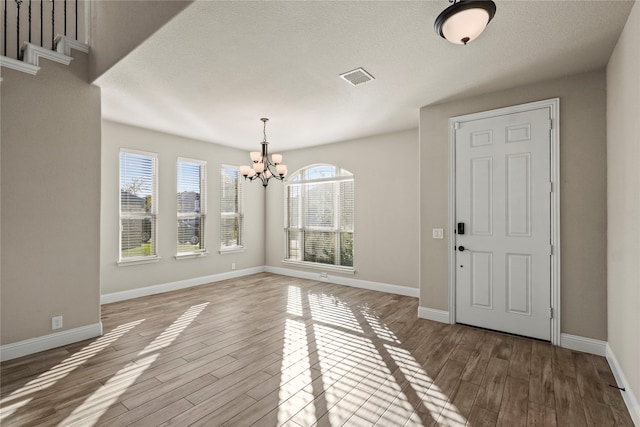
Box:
[285,165,354,270]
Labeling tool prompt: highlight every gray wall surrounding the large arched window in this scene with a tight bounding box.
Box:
[265,130,419,288]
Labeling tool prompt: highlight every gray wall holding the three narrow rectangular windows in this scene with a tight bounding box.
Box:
[100,121,264,294]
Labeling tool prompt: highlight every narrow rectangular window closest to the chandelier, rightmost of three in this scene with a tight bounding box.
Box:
[220,165,244,252]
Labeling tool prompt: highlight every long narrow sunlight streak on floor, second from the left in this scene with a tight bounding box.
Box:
[62,302,209,425]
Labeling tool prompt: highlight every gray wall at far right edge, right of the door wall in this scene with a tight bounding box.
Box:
[607,1,640,420]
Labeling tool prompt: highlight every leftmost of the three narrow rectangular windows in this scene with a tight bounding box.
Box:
[119,149,158,262]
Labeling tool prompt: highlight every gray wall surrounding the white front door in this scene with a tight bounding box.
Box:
[420,71,607,340]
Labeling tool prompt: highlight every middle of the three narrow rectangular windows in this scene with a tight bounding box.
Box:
[176,158,207,256]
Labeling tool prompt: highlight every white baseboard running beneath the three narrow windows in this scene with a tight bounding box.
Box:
[100,266,265,304]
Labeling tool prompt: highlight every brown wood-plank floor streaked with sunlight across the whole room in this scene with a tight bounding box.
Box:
[0,273,633,427]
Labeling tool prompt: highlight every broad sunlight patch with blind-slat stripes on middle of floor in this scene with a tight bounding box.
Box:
[277,286,467,427]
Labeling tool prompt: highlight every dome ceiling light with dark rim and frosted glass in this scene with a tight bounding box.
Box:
[434,0,496,44]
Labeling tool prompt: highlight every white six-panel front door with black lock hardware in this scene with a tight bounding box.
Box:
[454,108,551,340]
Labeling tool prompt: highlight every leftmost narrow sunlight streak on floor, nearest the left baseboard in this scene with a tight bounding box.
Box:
[0,319,145,421]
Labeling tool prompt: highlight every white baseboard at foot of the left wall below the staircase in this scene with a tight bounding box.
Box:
[0,323,102,362]
